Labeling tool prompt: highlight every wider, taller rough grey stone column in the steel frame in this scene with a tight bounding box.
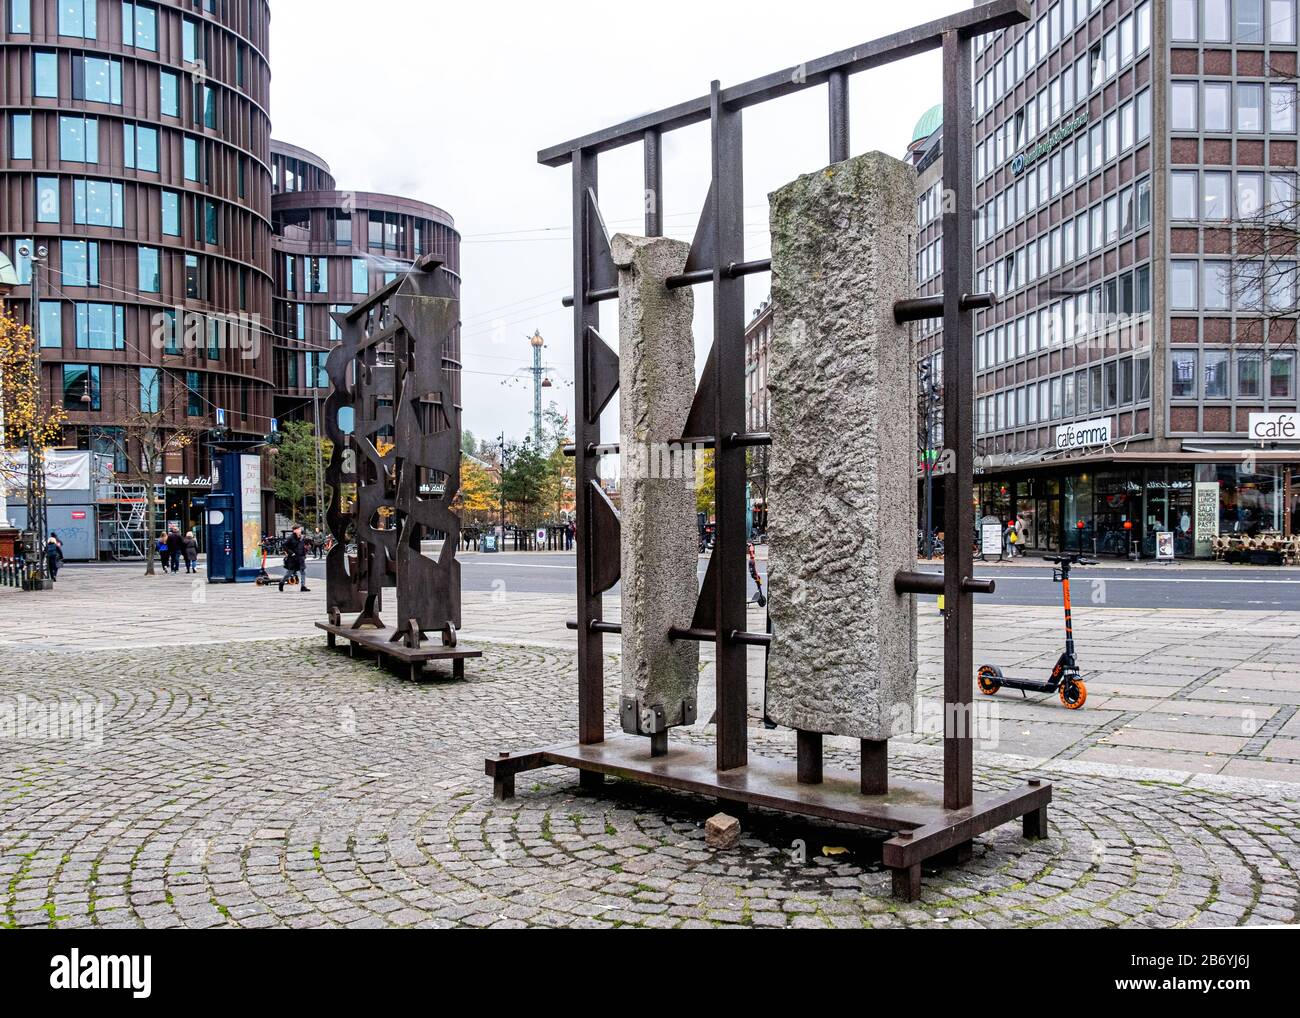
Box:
[767,152,917,741]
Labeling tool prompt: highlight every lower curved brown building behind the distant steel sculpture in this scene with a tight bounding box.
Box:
[270,142,460,420]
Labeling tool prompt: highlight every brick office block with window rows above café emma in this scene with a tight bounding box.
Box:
[913,0,1300,558]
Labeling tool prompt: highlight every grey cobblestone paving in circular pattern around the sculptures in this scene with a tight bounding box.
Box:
[0,640,1300,927]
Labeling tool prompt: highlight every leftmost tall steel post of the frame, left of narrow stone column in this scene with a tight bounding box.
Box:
[573,150,605,759]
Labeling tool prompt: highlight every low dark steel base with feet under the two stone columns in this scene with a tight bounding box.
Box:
[484,736,1052,901]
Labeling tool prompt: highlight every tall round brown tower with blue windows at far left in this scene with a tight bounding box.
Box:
[0,0,274,533]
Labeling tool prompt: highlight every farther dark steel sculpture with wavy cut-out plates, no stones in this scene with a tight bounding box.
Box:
[316,255,481,677]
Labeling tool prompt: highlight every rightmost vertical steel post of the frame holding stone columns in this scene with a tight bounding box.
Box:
[944,30,975,810]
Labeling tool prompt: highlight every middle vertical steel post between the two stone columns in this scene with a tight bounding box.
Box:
[710,81,749,771]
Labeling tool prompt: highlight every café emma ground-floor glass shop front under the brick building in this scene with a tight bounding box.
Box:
[975,451,1300,559]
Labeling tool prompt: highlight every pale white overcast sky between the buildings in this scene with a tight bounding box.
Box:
[270,0,970,447]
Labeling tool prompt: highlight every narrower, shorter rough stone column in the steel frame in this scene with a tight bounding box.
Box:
[611,234,699,735]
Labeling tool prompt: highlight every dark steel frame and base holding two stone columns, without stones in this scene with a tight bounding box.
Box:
[485,0,1052,900]
